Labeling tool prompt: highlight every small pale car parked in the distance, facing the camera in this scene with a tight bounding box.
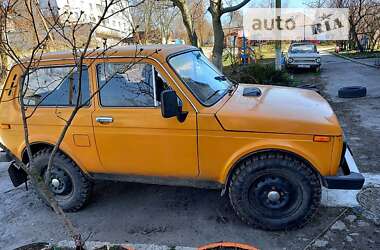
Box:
[285,42,321,72]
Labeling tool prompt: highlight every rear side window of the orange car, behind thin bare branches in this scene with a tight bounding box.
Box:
[24,66,90,106]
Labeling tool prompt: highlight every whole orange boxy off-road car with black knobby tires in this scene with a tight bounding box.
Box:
[0,45,364,230]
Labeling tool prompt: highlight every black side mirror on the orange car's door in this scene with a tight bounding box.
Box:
[161,89,187,122]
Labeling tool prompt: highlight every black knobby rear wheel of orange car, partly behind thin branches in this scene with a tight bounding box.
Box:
[34,149,92,212]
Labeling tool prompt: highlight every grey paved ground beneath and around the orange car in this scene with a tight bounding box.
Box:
[0,51,380,250]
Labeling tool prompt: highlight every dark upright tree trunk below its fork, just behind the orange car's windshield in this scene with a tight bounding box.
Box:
[212,15,224,70]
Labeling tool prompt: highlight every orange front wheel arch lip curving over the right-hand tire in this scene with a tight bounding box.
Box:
[222,148,322,195]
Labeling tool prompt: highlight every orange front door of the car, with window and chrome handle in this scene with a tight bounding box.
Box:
[92,58,198,177]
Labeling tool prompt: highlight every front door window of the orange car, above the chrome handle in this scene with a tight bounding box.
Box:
[97,63,157,107]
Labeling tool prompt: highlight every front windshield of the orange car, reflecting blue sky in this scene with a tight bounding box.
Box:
[169,51,232,106]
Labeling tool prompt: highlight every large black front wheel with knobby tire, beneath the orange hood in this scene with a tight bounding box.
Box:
[229,153,321,230]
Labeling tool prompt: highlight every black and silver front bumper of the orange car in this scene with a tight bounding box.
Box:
[322,146,365,190]
